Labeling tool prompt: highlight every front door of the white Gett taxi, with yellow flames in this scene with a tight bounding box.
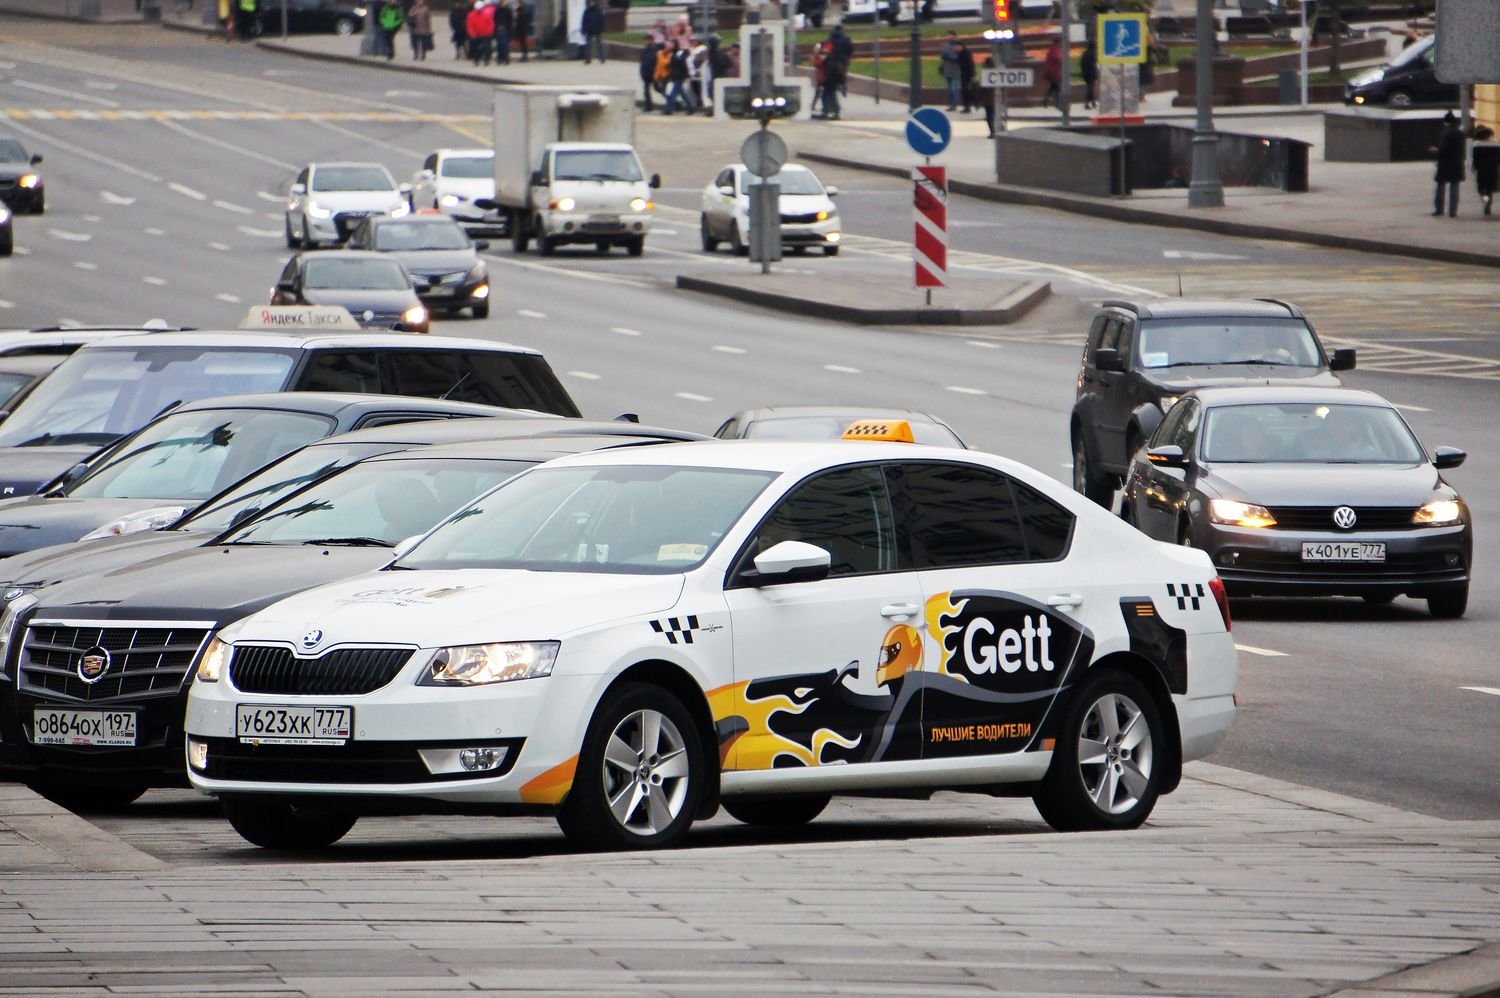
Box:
[725,465,923,770]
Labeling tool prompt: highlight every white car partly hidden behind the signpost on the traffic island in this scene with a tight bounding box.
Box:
[699,164,842,257]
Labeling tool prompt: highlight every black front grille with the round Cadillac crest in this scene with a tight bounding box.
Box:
[21,621,209,702]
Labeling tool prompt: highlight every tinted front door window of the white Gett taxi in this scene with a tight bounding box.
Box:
[741,467,896,575]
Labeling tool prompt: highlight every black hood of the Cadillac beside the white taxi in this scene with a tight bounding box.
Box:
[38,545,392,618]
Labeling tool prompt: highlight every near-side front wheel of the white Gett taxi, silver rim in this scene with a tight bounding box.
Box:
[558,683,707,851]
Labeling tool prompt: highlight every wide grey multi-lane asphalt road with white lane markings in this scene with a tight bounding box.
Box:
[0,21,1500,818]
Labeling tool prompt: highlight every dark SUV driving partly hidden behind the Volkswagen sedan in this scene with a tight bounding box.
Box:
[1068,299,1355,506]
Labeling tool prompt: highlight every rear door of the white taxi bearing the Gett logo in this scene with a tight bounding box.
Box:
[891,462,1092,759]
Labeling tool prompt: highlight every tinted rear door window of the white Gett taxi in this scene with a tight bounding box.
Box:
[899,464,1026,569]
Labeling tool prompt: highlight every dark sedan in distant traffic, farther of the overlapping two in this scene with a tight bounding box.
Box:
[345,213,491,318]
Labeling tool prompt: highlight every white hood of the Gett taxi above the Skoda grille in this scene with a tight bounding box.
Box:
[233,569,683,651]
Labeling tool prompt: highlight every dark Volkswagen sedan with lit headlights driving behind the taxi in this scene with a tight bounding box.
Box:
[1122,387,1473,617]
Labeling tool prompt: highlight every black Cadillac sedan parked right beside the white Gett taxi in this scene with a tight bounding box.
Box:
[0,420,708,807]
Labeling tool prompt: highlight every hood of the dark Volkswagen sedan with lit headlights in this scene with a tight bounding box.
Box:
[1202,464,1442,507]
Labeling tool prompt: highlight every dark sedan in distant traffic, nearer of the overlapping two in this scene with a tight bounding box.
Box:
[270,249,429,333]
